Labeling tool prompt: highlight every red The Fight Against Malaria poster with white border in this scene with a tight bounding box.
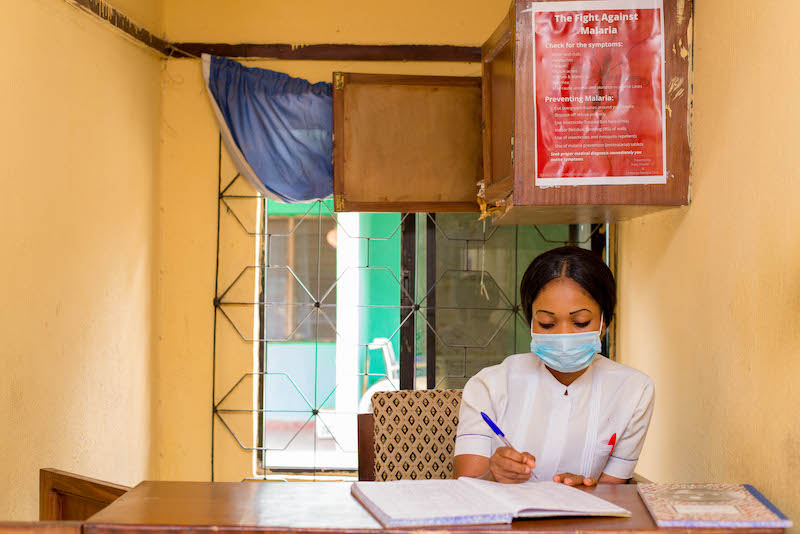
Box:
[531,0,666,187]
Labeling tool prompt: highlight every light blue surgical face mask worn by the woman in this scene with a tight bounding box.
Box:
[531,319,603,373]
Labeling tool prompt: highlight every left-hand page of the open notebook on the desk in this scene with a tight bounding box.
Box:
[353,480,512,526]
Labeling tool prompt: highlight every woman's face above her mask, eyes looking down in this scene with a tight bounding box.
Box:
[532,277,605,336]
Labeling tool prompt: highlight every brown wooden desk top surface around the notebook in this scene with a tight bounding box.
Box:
[83,482,782,534]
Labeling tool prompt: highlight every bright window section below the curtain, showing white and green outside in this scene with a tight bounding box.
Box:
[257,202,401,472]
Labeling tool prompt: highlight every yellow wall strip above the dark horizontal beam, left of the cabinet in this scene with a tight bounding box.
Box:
[164,0,511,46]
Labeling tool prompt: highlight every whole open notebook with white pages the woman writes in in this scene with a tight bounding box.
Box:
[350,477,631,527]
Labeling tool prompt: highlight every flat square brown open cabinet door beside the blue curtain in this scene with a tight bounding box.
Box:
[333,72,483,212]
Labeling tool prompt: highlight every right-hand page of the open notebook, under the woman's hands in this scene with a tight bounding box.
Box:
[459,478,630,517]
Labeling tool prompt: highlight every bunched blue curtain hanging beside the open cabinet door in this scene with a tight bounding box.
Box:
[203,55,333,203]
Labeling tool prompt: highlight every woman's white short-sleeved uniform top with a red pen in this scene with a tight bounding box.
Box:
[455,353,653,481]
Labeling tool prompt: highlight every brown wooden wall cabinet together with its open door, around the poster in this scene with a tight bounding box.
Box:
[334,0,693,224]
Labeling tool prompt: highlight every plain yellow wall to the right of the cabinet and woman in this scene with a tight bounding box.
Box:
[618,0,800,523]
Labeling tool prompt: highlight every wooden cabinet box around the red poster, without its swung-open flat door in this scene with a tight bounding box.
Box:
[481,0,692,224]
